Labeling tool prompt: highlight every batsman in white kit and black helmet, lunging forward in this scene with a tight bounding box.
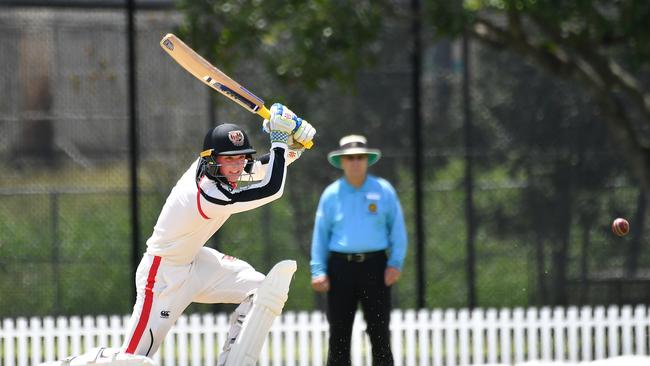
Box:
[122,103,316,366]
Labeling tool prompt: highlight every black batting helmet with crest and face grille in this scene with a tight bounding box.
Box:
[200,123,255,179]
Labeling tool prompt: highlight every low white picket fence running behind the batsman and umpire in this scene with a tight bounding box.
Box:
[0,306,650,366]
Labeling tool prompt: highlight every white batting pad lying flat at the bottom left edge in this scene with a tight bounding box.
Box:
[40,348,156,366]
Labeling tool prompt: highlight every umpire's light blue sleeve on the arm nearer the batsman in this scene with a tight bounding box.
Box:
[309,191,331,278]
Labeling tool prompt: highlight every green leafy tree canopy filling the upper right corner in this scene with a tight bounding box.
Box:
[427,0,650,192]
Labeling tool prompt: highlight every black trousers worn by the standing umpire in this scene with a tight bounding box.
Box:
[327,253,393,366]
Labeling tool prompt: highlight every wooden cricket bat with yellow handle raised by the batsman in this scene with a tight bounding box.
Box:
[160,33,314,149]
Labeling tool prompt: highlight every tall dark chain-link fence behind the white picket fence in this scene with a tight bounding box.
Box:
[0,3,650,316]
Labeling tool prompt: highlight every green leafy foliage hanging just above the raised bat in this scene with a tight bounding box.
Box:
[175,0,390,89]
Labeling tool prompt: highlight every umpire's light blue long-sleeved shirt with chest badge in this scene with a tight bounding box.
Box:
[310,175,407,277]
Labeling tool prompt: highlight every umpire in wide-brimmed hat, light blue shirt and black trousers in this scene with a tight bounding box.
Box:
[311,135,407,366]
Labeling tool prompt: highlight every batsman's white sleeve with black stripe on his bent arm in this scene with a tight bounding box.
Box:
[199,143,287,217]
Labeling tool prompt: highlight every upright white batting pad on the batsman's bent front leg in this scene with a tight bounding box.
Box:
[221,260,297,366]
